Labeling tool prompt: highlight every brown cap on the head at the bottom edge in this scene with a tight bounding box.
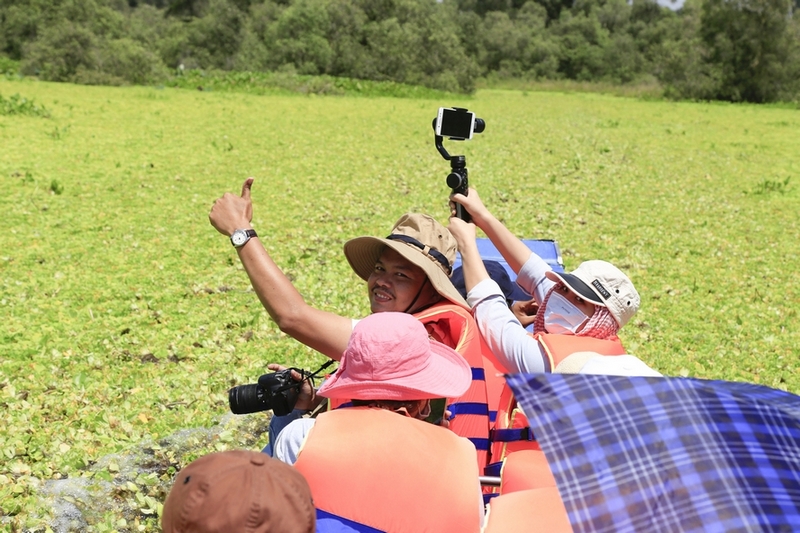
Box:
[161,450,316,533]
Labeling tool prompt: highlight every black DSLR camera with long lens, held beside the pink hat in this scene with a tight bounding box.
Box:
[228,360,334,416]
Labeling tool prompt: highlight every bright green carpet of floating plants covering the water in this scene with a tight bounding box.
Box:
[0,80,800,531]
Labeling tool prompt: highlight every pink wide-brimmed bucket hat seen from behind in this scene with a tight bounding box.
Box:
[319,312,472,400]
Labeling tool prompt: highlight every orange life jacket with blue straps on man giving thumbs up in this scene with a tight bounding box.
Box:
[328,302,496,470]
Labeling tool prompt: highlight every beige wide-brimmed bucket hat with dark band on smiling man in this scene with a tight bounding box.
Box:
[344,213,469,309]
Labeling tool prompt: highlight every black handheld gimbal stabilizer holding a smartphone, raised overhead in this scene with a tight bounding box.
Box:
[433,107,486,222]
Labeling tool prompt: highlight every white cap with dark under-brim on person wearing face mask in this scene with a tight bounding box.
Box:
[545,260,640,327]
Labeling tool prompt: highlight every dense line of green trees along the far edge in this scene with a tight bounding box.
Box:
[0,0,800,102]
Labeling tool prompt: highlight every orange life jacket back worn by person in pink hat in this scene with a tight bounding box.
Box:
[294,407,483,533]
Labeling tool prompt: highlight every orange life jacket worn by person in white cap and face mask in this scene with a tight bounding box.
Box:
[485,333,626,476]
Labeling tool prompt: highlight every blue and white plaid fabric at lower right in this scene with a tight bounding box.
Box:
[507,374,800,533]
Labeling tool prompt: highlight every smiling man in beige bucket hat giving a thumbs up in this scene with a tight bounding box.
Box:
[209,178,489,466]
